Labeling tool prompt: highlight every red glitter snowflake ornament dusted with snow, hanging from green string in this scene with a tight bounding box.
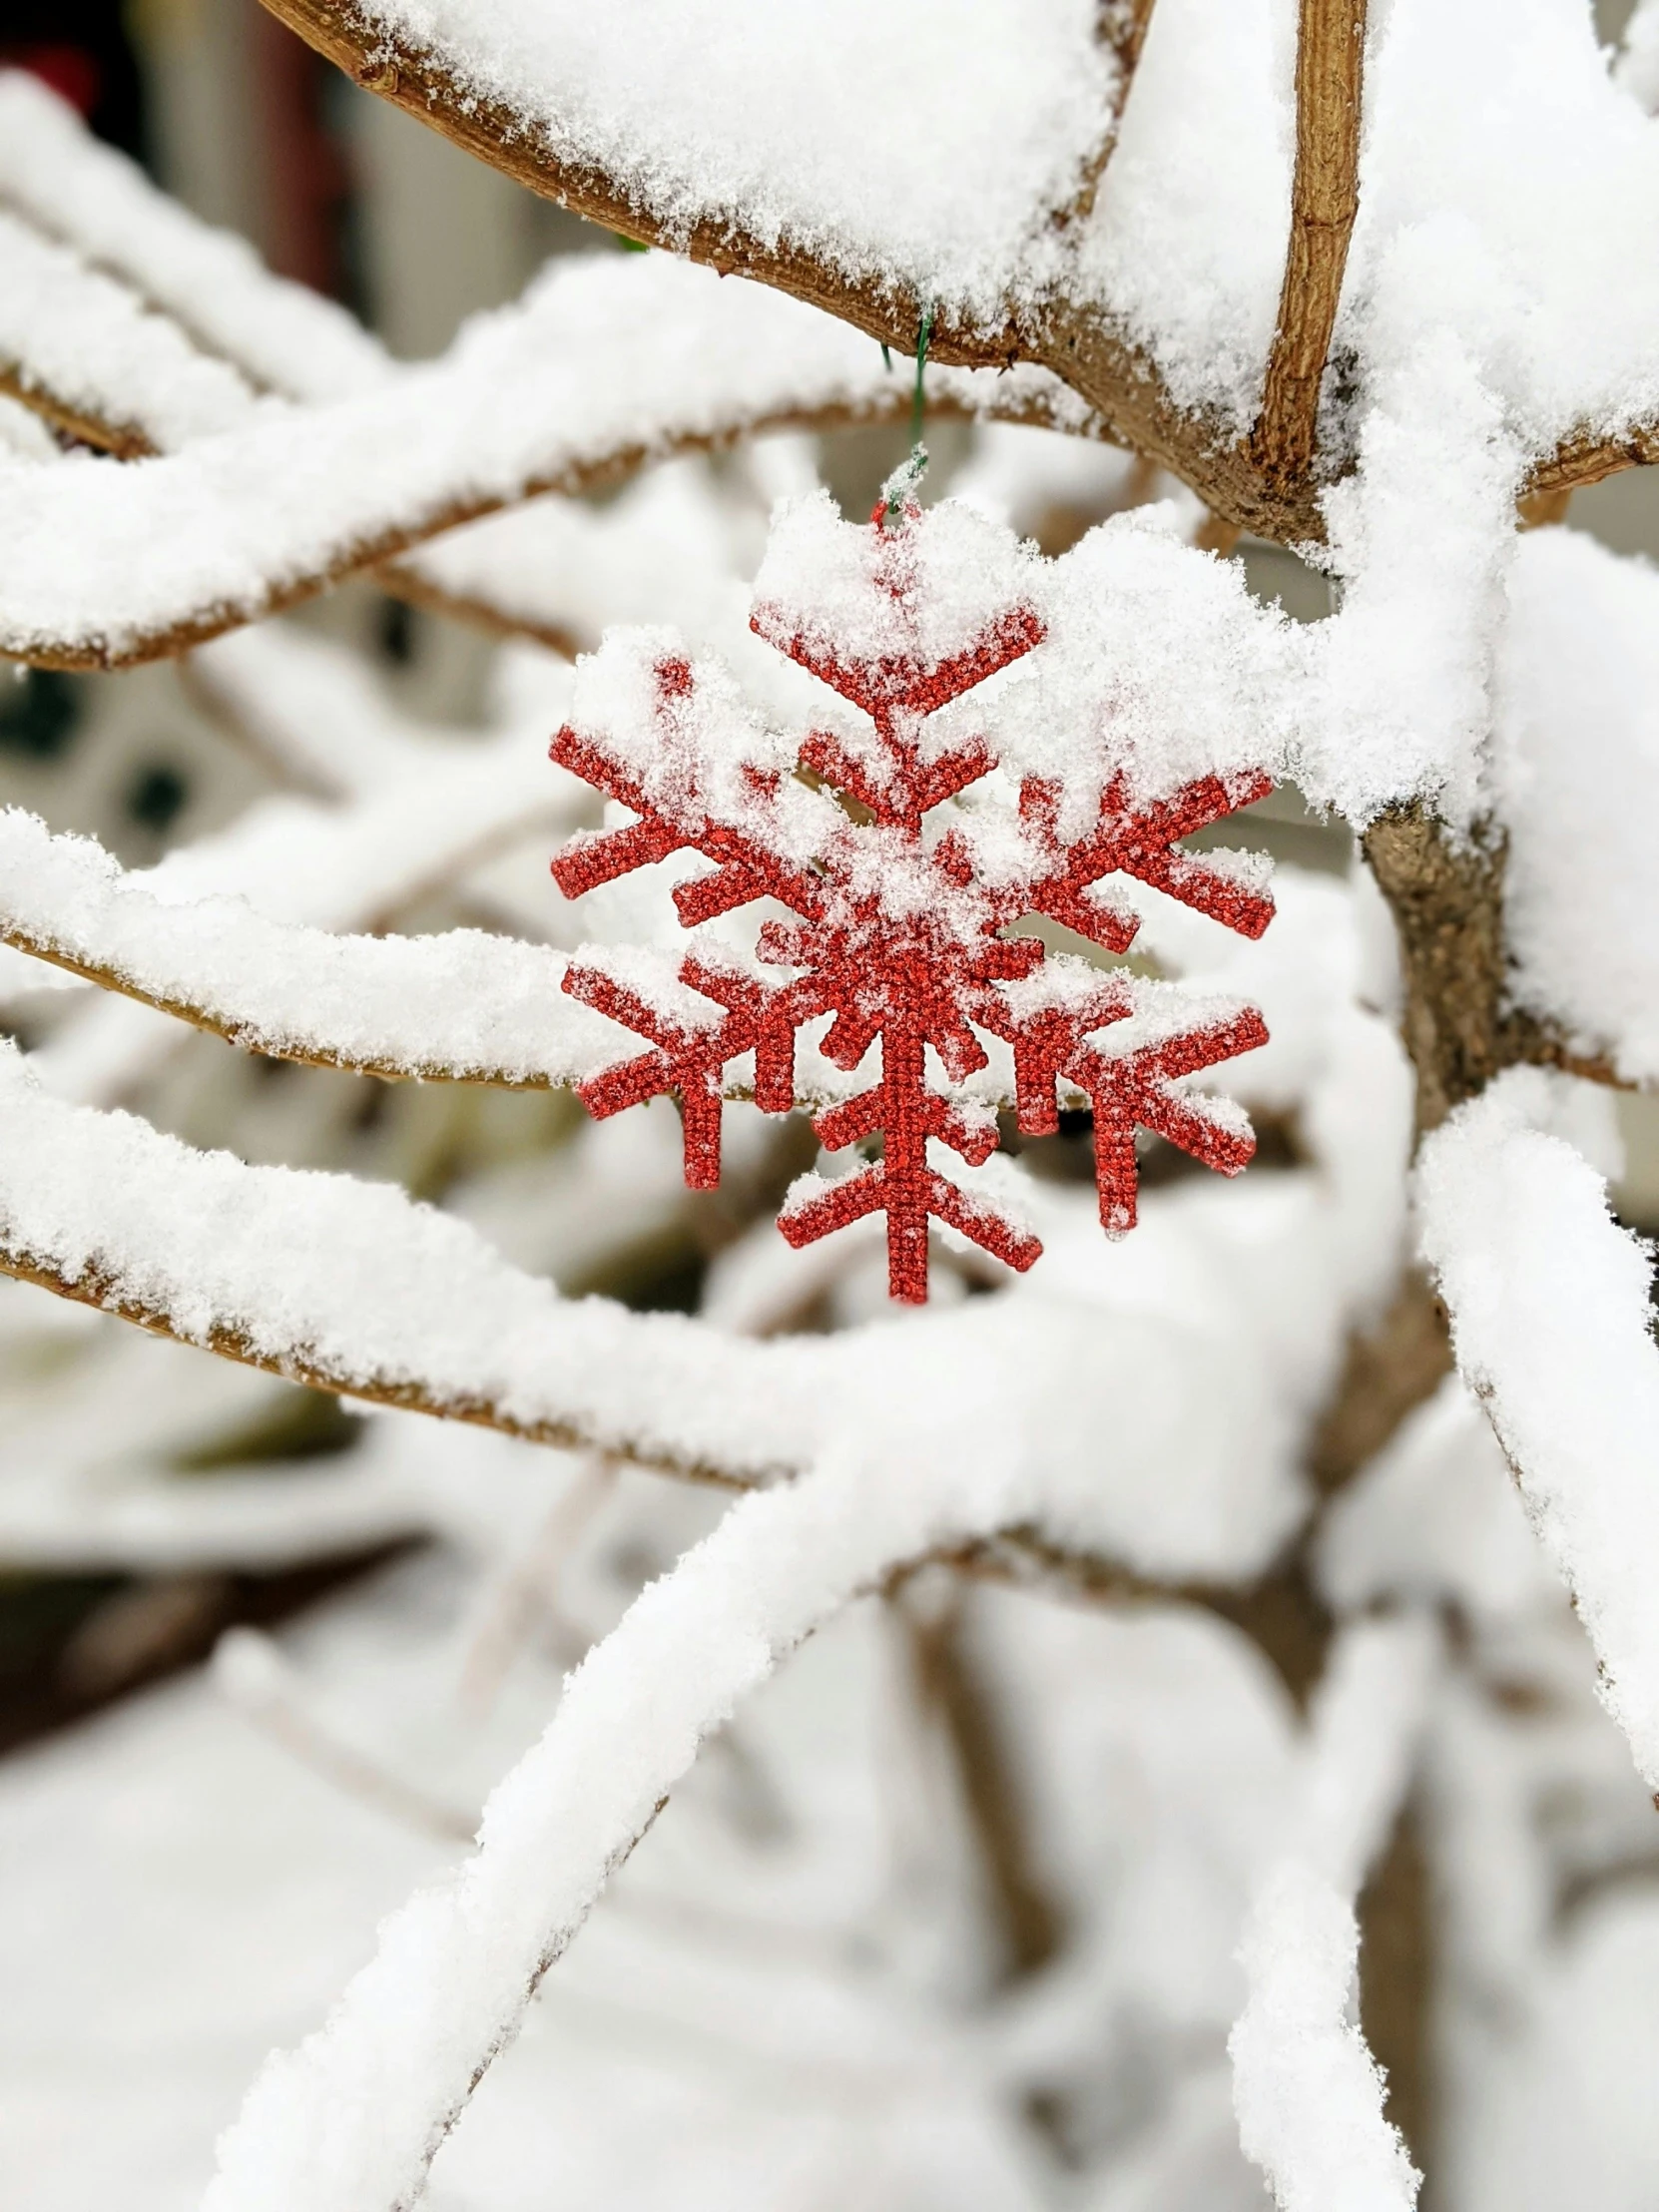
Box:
[551,473,1272,1301]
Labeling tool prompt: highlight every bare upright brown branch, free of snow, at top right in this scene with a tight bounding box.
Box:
[1250,0,1365,489]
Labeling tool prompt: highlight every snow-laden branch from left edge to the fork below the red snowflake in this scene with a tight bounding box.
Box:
[0,1046,823,1482]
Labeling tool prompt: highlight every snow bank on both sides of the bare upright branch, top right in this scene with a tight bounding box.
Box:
[1073,0,1659,453]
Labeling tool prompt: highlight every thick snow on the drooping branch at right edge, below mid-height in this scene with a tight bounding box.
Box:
[1417,1068,1659,1788]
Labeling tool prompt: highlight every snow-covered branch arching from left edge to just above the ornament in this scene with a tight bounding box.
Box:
[0,255,1088,668]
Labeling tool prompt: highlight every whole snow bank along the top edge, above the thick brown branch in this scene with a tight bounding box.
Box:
[326,0,1659,464]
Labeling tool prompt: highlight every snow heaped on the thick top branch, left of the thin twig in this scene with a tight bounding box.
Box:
[335,0,1115,323]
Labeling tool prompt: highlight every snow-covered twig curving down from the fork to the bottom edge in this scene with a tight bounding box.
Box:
[204,1432,1052,2212]
